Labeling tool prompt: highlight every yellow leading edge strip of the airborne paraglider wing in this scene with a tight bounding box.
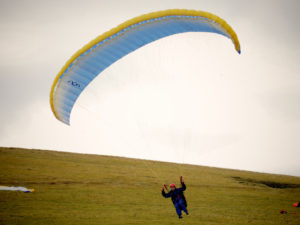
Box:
[50,9,240,119]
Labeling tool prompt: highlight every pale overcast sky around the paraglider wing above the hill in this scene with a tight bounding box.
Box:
[0,0,300,176]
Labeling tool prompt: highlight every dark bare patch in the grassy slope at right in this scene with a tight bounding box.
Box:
[232,177,300,189]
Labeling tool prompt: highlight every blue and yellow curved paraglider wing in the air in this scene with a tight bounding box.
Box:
[50,9,240,124]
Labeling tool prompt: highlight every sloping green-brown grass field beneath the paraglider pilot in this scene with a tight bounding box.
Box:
[0,148,300,225]
